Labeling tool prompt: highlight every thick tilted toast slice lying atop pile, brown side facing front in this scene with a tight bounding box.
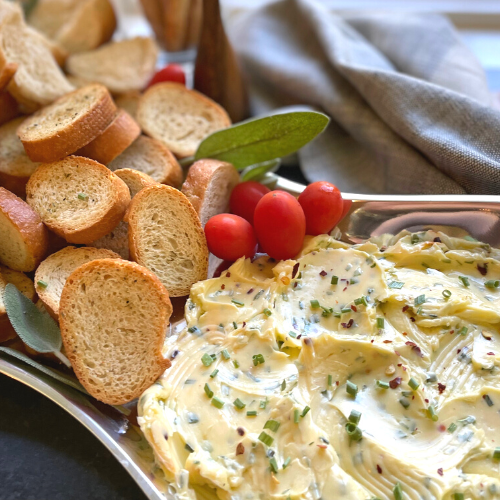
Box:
[18,84,116,162]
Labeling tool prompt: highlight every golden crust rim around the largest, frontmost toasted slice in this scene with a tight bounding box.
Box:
[59,259,172,405]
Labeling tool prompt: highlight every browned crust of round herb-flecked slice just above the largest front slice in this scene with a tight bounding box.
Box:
[26,156,130,244]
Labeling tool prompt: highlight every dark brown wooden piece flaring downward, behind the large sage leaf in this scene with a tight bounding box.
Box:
[194,0,249,123]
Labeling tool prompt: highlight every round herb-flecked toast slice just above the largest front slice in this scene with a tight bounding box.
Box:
[26,156,130,243]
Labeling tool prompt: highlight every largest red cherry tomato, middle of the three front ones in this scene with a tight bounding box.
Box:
[253,191,306,260]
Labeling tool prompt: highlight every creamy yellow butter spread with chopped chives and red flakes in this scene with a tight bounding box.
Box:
[139,231,500,500]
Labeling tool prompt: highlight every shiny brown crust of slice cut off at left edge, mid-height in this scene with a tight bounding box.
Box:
[0,187,49,272]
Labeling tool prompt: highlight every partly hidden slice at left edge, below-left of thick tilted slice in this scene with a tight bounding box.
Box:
[0,118,39,198]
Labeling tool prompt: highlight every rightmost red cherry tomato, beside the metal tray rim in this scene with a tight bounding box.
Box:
[299,181,344,236]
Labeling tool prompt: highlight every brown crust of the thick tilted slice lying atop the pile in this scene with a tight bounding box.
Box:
[17,84,116,163]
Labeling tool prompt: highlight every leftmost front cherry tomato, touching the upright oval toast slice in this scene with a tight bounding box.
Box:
[205,214,257,261]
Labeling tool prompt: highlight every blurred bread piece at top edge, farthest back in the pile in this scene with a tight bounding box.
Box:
[28,0,116,53]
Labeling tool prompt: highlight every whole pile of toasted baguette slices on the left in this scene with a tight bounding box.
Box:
[0,0,239,404]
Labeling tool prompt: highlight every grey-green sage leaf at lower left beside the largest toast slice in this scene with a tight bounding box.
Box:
[4,283,62,352]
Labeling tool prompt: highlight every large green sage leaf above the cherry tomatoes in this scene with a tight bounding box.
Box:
[194,111,330,170]
